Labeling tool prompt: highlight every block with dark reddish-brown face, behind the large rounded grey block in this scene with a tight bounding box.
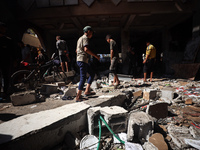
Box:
[146,102,168,119]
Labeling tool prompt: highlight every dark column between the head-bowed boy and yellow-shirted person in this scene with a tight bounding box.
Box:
[121,29,130,73]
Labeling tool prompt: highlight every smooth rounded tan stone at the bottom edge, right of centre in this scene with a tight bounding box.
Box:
[149,133,168,150]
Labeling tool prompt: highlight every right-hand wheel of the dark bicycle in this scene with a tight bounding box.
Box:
[53,66,67,84]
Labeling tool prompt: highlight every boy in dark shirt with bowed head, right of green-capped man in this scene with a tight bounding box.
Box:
[106,35,120,85]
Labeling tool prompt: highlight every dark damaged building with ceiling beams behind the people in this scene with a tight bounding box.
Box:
[1,0,200,78]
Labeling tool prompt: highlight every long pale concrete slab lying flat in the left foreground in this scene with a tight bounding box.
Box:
[0,103,90,149]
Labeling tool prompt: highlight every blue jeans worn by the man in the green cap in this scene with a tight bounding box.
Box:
[77,61,95,90]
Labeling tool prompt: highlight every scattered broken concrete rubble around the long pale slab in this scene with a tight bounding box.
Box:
[2,72,200,150]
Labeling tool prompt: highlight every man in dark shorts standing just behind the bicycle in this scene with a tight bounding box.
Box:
[56,36,70,72]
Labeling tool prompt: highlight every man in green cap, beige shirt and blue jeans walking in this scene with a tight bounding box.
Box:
[76,26,100,102]
